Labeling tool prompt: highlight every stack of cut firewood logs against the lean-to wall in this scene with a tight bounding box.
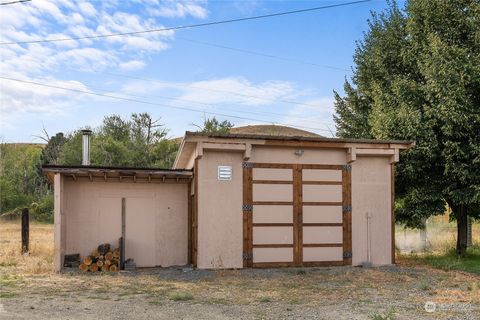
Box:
[79,243,120,272]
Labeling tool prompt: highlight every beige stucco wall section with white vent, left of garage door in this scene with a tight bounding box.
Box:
[197,150,243,268]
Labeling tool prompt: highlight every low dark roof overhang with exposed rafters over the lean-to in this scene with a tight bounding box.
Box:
[42,165,193,184]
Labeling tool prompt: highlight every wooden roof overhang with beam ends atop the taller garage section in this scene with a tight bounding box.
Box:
[173,131,415,168]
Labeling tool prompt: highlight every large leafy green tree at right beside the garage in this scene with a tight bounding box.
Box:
[335,0,480,254]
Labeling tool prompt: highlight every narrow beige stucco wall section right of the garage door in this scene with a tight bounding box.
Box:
[352,157,392,265]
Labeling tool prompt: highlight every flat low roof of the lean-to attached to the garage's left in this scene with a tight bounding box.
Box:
[42,165,193,183]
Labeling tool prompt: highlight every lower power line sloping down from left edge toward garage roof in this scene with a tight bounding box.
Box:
[0,76,330,132]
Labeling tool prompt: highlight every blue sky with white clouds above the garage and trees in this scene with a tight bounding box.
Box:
[0,0,398,142]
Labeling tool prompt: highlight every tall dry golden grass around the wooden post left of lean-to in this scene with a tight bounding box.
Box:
[0,220,53,274]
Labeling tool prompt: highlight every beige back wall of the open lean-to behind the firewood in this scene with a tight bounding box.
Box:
[60,178,188,267]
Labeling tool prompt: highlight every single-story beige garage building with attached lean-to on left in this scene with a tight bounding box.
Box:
[43,132,414,270]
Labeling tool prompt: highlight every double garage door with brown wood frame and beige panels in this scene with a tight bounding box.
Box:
[243,162,351,267]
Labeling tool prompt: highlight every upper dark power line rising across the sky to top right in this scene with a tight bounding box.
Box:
[0,0,371,45]
